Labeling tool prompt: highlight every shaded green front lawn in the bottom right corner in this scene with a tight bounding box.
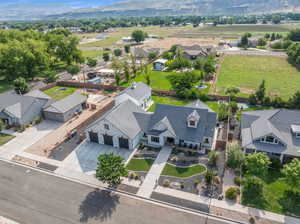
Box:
[242,170,300,217]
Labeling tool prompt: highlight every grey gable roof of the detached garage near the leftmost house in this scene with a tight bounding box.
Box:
[44,92,87,113]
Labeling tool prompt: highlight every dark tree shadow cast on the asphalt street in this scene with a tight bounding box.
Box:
[79,189,119,223]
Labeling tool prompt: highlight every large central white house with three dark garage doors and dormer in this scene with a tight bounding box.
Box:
[86,100,217,153]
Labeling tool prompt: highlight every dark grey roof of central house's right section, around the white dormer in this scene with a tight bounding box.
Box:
[147,104,217,142]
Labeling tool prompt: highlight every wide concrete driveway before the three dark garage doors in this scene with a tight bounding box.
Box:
[63,141,134,174]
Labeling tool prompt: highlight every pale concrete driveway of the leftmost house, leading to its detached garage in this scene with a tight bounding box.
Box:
[0,120,62,160]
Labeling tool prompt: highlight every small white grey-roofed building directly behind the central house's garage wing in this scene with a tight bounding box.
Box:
[115,82,153,111]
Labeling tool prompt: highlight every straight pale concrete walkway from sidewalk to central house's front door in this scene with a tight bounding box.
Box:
[137,146,172,198]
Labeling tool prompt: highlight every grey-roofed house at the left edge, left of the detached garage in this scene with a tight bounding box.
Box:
[0,90,53,126]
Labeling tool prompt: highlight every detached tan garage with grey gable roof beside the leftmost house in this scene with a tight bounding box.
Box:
[44,92,87,122]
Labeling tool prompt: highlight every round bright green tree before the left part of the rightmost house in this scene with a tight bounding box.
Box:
[245,152,271,176]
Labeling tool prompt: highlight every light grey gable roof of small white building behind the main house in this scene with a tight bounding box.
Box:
[119,82,151,101]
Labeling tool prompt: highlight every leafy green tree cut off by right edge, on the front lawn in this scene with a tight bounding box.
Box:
[282,158,300,189]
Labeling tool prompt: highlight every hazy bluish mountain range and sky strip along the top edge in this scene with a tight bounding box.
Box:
[0,0,300,20]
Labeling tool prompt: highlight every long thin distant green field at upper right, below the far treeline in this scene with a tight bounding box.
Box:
[174,24,292,39]
